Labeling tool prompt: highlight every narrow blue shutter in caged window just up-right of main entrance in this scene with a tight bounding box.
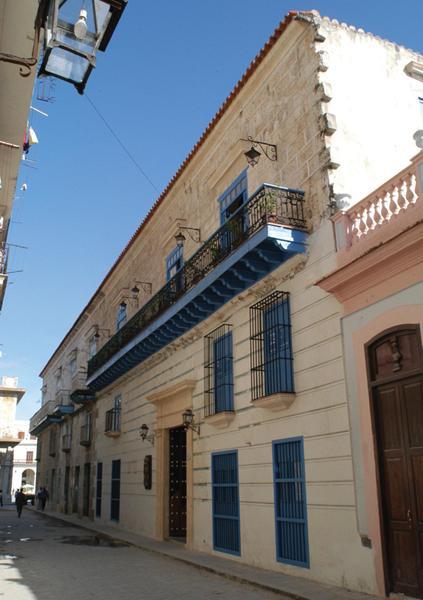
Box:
[214,331,234,412]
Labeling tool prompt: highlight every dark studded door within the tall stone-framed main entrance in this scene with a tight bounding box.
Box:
[169,427,187,538]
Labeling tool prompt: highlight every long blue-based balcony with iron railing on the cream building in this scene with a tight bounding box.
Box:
[87,184,307,391]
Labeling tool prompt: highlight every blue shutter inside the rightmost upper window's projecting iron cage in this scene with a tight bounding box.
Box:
[263,298,294,396]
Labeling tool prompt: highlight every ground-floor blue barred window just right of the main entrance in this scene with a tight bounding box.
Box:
[212,450,241,555]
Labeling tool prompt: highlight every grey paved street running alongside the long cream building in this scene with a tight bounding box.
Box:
[0,507,287,600]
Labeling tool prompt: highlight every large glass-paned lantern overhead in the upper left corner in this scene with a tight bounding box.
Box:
[38,0,127,94]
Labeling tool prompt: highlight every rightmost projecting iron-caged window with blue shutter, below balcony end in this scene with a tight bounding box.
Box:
[250,291,294,400]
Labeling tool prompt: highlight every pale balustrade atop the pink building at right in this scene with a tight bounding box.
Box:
[333,151,423,261]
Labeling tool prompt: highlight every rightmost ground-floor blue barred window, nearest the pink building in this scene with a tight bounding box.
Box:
[273,437,310,567]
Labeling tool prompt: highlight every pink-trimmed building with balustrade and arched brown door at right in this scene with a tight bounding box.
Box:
[318,151,423,597]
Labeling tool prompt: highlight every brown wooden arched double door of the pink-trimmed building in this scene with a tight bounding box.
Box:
[369,326,423,598]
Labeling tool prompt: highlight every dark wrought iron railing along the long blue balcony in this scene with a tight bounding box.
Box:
[88,183,307,377]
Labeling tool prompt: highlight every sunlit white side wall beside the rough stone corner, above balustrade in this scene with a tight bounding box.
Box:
[320,20,423,207]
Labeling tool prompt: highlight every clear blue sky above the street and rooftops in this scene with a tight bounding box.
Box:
[4,0,423,418]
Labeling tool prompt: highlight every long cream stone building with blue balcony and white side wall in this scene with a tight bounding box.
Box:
[31,12,423,595]
